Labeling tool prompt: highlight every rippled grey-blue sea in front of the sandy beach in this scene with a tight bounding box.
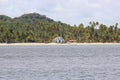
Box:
[0,44,120,80]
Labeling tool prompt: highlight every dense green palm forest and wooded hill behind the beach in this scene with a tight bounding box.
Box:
[0,13,120,43]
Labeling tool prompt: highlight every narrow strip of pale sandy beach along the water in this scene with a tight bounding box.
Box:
[0,43,120,46]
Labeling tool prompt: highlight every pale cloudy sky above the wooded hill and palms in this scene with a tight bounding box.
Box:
[0,0,120,25]
